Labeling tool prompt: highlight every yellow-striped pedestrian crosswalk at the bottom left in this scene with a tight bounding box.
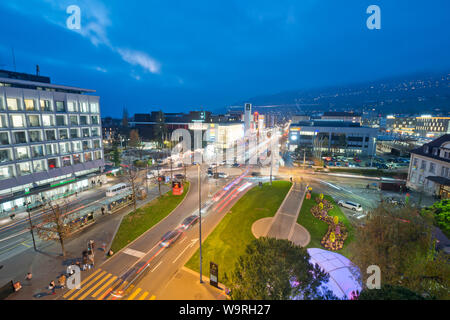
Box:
[62,268,156,300]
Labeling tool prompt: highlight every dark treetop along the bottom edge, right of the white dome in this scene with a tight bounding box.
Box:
[358,284,425,300]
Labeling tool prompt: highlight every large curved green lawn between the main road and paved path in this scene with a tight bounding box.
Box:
[186,181,291,282]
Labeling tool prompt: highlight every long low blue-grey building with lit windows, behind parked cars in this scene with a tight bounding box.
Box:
[289,120,378,156]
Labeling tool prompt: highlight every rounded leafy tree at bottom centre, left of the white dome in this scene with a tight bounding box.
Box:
[230,237,335,300]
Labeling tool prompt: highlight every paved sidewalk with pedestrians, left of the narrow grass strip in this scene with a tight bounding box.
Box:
[0,186,169,300]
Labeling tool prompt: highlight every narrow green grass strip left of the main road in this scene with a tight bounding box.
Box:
[111,182,189,252]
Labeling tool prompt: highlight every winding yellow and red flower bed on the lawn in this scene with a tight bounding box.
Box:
[311,195,348,251]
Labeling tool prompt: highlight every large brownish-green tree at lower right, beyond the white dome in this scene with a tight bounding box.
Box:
[351,204,450,299]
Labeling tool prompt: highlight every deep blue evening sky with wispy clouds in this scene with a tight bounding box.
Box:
[0,0,450,117]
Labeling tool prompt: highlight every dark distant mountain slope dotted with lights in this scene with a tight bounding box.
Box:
[241,72,450,114]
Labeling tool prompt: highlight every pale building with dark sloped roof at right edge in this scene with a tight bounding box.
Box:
[406,134,450,199]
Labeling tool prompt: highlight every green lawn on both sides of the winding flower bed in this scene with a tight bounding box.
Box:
[297,193,354,258]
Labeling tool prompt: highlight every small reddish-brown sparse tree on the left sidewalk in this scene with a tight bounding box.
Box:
[35,202,70,257]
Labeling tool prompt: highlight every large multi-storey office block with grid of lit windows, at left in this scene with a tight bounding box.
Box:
[0,72,104,214]
